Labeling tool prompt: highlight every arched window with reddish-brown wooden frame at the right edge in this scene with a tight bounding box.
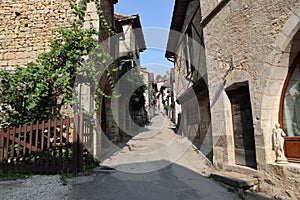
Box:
[279,54,300,137]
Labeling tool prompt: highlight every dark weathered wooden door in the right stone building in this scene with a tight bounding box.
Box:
[229,86,256,168]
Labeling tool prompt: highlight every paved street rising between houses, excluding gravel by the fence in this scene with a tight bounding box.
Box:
[68,115,240,200]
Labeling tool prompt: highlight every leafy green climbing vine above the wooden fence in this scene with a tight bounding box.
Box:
[0,0,118,127]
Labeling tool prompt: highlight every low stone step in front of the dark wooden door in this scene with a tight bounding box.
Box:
[210,172,258,189]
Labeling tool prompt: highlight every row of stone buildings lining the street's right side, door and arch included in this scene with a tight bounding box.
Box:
[166,0,300,199]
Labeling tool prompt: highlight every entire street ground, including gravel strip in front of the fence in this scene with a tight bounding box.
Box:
[0,113,266,200]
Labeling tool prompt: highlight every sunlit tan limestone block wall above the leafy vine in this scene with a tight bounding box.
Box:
[0,0,75,70]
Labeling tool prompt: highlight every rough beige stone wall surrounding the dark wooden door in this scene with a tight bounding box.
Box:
[200,0,299,168]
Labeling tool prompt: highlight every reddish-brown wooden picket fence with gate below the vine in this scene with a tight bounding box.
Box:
[0,113,91,174]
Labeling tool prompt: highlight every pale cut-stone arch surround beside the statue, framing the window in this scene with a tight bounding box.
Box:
[259,6,300,163]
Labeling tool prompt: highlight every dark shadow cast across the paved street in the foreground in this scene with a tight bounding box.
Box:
[68,160,268,200]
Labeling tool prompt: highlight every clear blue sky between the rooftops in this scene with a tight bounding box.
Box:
[115,0,175,75]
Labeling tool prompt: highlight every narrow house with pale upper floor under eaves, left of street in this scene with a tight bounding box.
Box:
[114,13,146,139]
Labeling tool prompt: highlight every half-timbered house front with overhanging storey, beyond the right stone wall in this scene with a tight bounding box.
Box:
[174,0,213,160]
